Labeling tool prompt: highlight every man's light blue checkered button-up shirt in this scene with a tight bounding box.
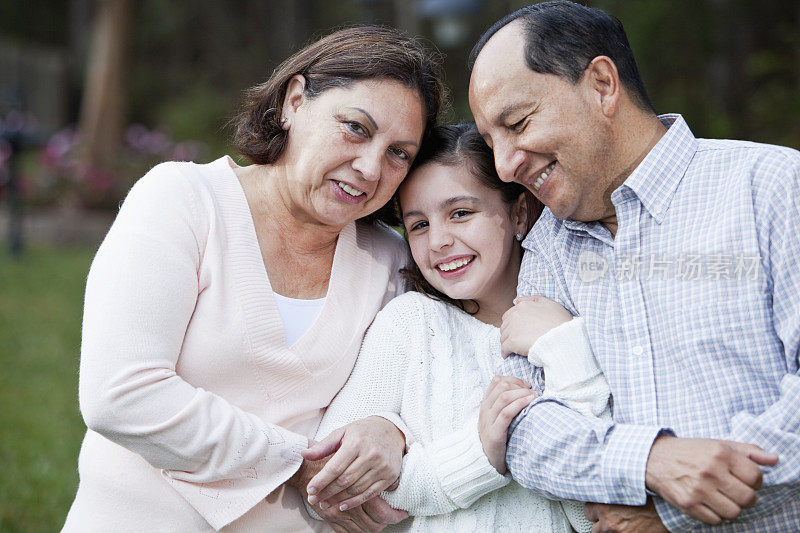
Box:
[499,115,800,532]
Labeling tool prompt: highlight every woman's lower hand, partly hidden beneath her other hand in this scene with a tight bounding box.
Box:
[287,448,408,533]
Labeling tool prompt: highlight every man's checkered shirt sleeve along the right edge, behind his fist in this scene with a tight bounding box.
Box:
[655,148,800,531]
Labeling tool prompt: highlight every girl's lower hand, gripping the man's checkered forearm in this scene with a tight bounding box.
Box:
[478,376,539,474]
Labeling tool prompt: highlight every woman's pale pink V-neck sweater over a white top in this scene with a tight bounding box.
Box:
[64,157,407,532]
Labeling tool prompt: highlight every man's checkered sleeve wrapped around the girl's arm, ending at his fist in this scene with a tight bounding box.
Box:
[506,235,671,505]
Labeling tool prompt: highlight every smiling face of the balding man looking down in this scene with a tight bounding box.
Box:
[469,22,612,221]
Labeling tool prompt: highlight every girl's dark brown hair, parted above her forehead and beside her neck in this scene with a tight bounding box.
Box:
[398,122,544,315]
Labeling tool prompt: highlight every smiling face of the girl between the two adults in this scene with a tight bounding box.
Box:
[398,162,526,323]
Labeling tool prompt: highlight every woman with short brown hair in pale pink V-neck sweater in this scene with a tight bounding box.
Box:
[64,27,442,532]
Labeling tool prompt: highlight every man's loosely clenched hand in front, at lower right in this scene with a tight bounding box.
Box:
[645,436,778,525]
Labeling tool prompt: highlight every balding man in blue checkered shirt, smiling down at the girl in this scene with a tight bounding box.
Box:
[469,2,800,531]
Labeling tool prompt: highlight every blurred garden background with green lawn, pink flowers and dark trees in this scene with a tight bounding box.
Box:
[0,0,800,532]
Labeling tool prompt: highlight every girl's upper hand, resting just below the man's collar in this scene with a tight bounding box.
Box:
[500,296,572,359]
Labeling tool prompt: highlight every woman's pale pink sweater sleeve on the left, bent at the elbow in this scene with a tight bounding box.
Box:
[79,163,307,529]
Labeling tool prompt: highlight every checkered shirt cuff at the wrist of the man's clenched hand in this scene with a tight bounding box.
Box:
[601,424,671,505]
